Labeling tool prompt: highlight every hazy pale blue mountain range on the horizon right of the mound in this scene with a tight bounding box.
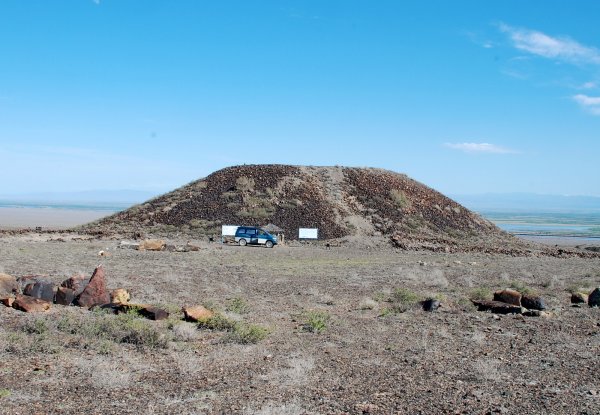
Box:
[450,193,600,213]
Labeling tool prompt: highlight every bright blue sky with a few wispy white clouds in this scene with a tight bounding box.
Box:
[0,0,600,196]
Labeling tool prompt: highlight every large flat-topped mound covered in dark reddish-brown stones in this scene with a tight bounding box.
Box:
[81,165,515,250]
